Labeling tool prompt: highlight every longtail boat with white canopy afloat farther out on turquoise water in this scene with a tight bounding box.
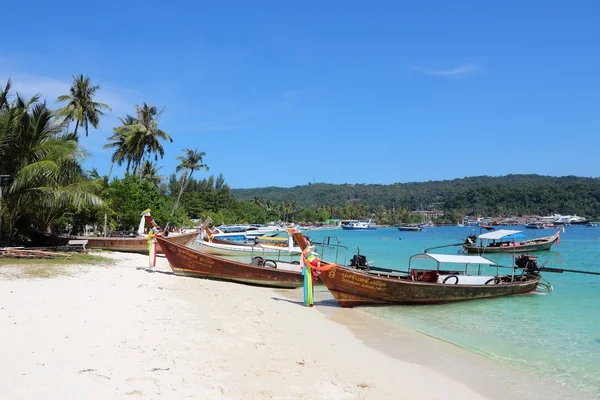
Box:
[463,229,560,254]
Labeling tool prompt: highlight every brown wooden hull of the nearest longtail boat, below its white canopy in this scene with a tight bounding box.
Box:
[319,266,540,307]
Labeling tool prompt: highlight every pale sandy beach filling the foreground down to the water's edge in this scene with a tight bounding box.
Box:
[0,253,583,400]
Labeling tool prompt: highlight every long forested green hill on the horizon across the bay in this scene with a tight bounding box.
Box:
[232,175,600,216]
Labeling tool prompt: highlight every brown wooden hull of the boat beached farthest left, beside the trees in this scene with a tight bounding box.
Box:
[30,231,198,254]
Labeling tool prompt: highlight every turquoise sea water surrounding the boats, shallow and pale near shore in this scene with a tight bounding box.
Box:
[307,226,600,398]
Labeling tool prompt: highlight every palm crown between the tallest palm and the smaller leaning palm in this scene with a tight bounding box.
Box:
[114,102,173,178]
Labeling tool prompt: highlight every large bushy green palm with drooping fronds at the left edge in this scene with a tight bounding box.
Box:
[0,88,103,235]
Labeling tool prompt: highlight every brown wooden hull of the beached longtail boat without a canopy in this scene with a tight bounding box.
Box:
[157,237,304,288]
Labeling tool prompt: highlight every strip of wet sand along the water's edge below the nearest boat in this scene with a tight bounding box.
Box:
[276,286,593,400]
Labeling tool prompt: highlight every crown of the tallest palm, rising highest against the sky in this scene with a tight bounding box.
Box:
[56,74,112,136]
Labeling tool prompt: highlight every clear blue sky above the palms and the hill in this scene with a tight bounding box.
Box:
[0,1,600,188]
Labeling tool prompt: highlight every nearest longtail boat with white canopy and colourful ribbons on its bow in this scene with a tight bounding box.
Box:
[294,233,551,307]
